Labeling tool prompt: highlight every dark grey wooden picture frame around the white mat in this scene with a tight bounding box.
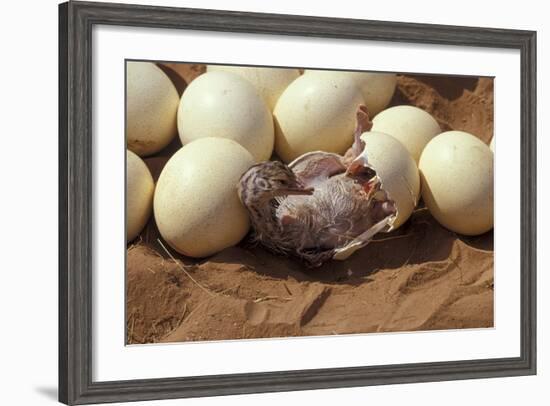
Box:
[59,2,536,404]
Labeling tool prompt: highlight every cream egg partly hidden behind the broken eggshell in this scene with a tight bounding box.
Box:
[372,106,441,164]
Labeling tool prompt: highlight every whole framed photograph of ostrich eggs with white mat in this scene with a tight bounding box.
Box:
[59,2,536,404]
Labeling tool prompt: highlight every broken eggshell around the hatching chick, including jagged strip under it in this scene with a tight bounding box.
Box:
[333,132,420,260]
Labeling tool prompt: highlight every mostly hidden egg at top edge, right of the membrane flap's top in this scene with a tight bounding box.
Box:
[304,70,397,118]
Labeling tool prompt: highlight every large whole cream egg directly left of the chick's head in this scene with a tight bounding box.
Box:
[154,137,254,258]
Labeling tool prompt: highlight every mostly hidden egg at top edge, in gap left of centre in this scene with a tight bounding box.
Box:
[207,65,300,111]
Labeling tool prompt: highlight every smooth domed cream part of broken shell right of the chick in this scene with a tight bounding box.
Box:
[361,131,420,231]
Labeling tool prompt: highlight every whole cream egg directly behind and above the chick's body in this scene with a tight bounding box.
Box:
[273,75,364,162]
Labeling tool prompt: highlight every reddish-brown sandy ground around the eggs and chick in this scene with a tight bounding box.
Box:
[126,64,494,344]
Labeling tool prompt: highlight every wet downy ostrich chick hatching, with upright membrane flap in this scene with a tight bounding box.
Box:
[238,106,396,267]
